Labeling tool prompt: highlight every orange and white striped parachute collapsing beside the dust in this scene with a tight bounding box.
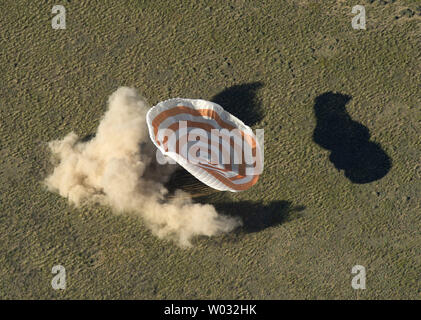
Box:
[146,98,263,192]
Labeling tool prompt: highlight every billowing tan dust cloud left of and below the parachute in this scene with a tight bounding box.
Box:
[45,87,241,247]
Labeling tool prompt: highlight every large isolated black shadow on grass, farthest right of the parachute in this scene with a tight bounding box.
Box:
[313,92,392,184]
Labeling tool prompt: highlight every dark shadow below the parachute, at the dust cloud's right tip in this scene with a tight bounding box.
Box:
[213,201,305,233]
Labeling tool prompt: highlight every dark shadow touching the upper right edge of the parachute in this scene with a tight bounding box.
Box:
[210,82,263,126]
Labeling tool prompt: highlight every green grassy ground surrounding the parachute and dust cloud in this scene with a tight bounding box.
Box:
[0,0,421,299]
